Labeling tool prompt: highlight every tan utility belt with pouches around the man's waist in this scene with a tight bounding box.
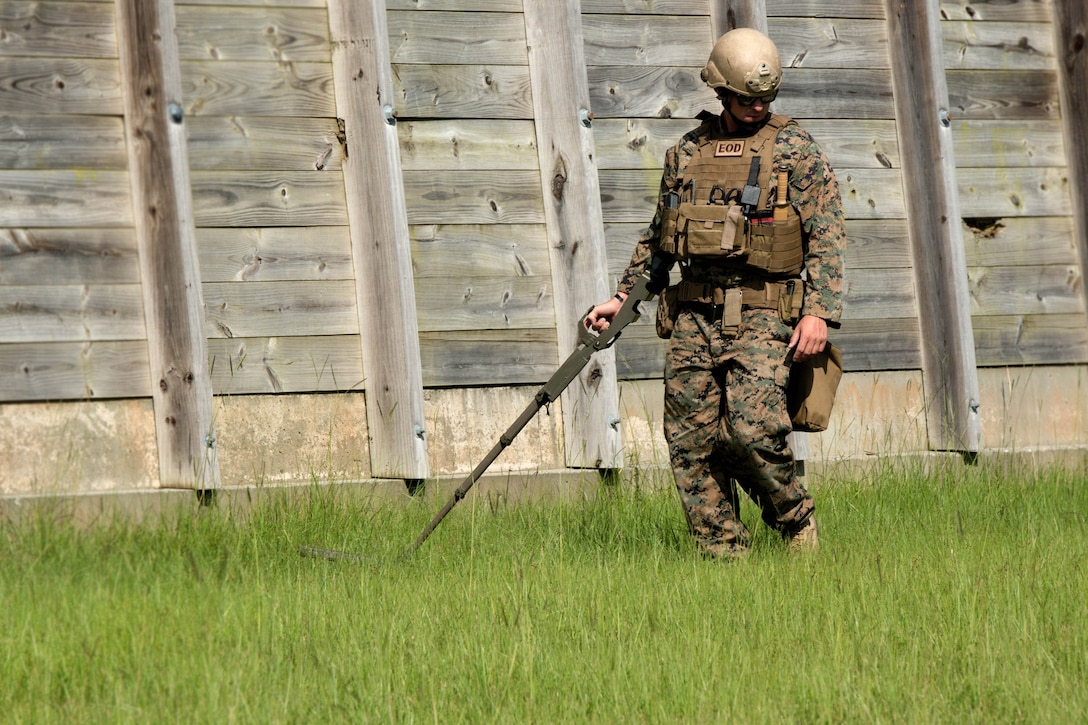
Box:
[656,279,805,340]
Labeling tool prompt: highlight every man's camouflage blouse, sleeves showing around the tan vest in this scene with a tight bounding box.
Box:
[618,113,846,327]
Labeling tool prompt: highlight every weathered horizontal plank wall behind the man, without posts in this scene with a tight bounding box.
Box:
[0,0,1088,485]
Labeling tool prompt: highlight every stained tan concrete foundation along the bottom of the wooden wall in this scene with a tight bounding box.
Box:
[0,366,1088,508]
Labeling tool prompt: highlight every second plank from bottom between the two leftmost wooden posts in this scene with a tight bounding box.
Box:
[203,280,359,337]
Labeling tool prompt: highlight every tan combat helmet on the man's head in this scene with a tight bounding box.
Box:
[700,27,782,97]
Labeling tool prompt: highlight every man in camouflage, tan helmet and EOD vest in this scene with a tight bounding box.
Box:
[586,28,845,557]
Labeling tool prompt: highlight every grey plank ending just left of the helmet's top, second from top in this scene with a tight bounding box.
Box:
[582,14,714,66]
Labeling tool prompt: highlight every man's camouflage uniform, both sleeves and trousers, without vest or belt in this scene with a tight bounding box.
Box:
[618,113,845,556]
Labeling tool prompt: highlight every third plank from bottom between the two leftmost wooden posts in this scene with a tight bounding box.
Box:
[197,226,355,282]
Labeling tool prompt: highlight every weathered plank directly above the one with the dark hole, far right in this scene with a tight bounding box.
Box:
[959,167,1073,218]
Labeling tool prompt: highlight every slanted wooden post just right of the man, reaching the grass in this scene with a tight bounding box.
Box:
[885,0,981,453]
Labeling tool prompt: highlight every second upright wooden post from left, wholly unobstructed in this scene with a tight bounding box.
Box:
[329,0,429,479]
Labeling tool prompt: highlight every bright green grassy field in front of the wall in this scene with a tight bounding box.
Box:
[0,465,1088,723]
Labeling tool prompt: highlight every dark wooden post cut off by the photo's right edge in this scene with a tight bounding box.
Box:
[1052,0,1088,322]
